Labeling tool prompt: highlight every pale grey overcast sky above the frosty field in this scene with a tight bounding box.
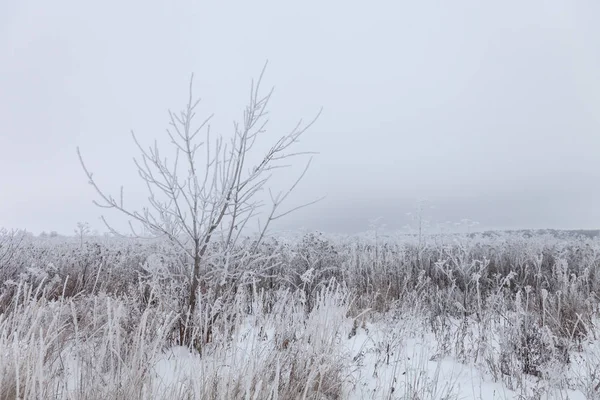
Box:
[0,0,600,234]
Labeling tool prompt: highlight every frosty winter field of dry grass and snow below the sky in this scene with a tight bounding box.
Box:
[0,231,600,400]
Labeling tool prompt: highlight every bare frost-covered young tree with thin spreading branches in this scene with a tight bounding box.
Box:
[77,65,320,345]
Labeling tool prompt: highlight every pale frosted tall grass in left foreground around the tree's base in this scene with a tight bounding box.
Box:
[0,285,350,399]
